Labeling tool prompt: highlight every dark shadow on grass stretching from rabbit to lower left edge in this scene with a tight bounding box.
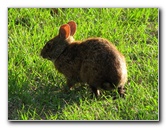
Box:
[8,73,90,120]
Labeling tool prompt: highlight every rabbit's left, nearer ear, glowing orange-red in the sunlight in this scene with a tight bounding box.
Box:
[59,24,70,39]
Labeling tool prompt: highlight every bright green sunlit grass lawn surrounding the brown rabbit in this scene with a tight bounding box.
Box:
[8,8,159,120]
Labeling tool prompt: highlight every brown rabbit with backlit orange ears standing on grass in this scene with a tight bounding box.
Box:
[41,21,127,97]
